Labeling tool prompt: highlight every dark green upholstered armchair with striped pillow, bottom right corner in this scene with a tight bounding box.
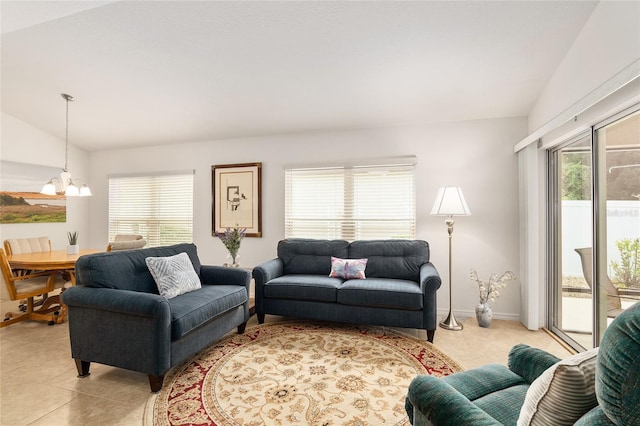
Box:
[405,303,640,426]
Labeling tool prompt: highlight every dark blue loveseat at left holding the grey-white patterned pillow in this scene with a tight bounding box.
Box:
[62,244,251,392]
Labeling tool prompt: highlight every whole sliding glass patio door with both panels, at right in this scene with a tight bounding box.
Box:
[548,109,640,349]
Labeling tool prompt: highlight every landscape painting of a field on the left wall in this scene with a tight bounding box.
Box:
[0,161,67,224]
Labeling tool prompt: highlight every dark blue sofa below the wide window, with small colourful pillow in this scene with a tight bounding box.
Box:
[253,239,441,342]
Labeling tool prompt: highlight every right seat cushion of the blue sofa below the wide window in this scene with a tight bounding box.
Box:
[338,278,424,311]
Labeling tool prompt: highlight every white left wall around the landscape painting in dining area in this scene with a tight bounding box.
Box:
[0,112,91,299]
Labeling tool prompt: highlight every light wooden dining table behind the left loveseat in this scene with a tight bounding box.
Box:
[7,249,104,285]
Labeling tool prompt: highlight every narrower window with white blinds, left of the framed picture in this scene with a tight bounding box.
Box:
[109,171,194,247]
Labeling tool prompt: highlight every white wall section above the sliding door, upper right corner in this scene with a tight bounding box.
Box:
[529,1,640,132]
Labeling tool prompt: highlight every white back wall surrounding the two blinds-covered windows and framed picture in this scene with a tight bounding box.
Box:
[89,118,527,319]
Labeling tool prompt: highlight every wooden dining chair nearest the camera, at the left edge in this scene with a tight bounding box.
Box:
[0,249,66,328]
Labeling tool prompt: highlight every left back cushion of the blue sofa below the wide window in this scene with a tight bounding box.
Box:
[278,238,349,276]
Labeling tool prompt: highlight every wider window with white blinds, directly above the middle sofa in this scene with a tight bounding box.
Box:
[285,159,416,241]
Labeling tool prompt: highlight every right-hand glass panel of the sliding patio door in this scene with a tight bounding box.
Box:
[593,111,640,336]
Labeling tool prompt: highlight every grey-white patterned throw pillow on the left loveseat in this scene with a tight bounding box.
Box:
[144,253,201,299]
